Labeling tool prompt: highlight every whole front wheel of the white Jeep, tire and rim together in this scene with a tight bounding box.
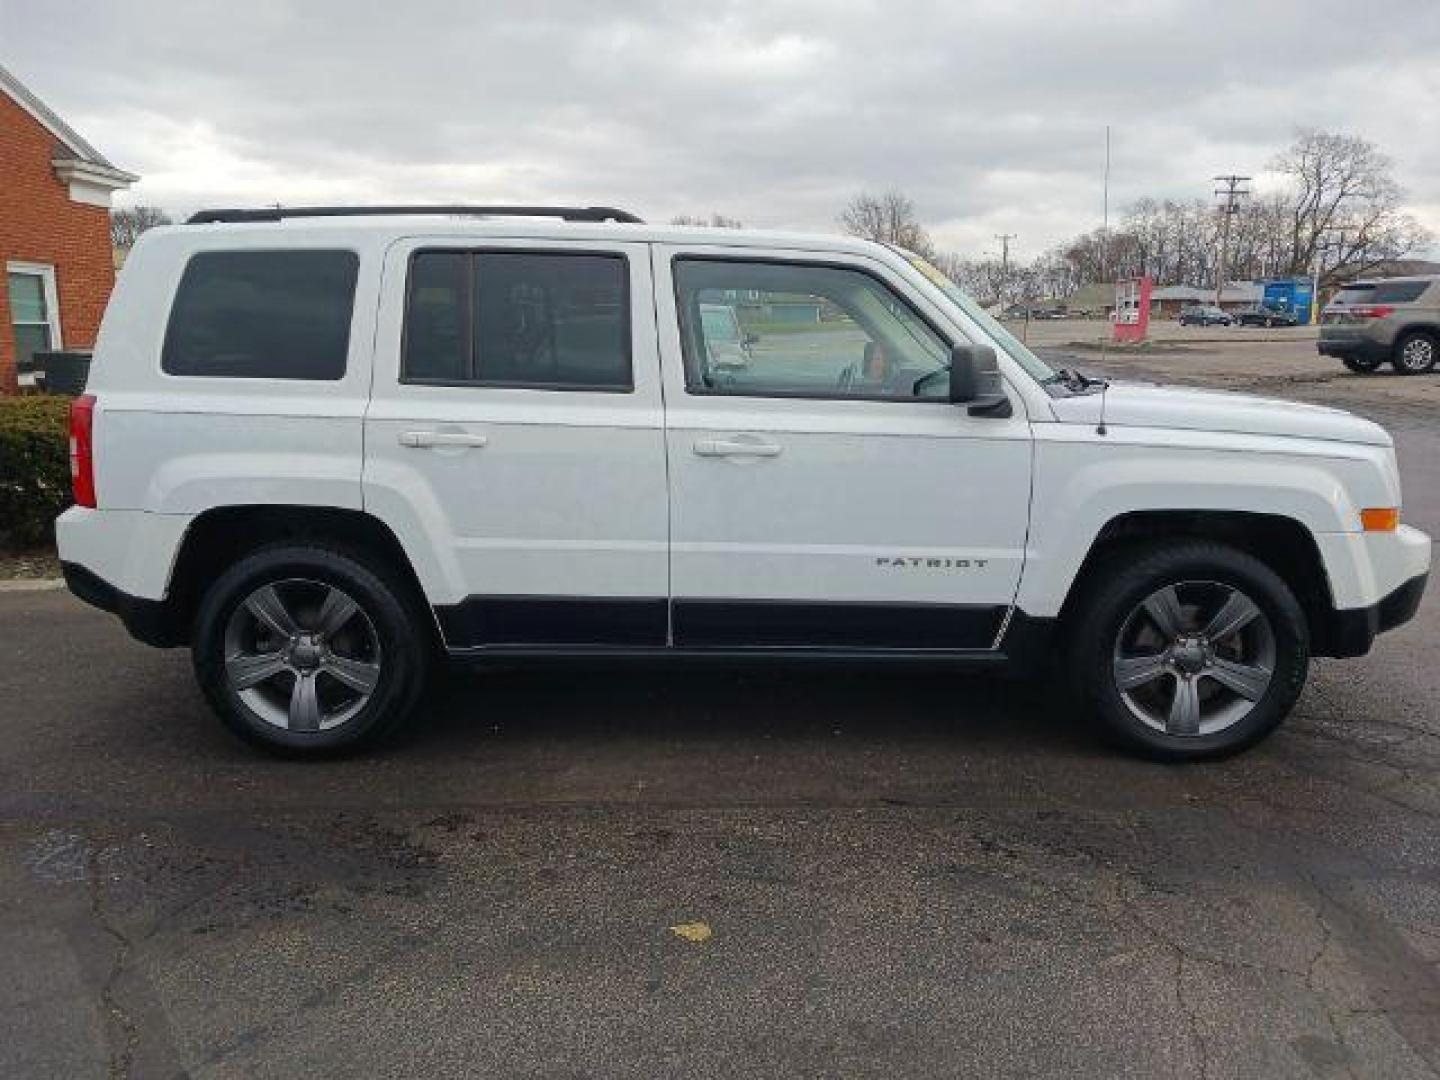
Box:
[1071,541,1309,760]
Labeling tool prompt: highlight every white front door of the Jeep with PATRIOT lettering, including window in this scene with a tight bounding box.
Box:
[654,246,1031,651]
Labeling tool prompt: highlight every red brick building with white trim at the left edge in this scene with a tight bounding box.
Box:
[0,68,138,393]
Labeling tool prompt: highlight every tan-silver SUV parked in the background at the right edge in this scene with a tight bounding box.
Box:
[1316,274,1440,374]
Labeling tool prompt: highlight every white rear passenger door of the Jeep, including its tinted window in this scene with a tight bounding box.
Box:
[364,239,668,649]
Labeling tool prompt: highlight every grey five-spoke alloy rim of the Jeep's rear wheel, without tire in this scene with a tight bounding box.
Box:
[225,577,380,732]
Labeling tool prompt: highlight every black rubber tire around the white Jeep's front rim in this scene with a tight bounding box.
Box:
[1067,540,1310,762]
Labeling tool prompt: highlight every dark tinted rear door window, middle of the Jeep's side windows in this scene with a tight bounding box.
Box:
[402,251,634,390]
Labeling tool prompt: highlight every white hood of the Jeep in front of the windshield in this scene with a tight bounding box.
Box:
[1053,383,1392,446]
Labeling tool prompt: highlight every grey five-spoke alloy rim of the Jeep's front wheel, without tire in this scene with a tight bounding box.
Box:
[1113,582,1276,736]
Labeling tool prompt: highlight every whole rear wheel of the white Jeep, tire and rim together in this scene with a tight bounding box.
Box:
[193,547,429,756]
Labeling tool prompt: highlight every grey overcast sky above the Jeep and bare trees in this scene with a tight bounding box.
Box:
[8,0,1440,256]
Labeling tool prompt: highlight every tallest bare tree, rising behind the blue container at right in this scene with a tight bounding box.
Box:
[1270,128,1430,281]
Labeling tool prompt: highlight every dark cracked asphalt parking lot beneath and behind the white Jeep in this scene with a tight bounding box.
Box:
[0,327,1440,1080]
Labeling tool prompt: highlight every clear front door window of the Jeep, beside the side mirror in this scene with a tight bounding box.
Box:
[675,258,949,400]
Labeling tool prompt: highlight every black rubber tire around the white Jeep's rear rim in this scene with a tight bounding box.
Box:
[192,544,433,757]
